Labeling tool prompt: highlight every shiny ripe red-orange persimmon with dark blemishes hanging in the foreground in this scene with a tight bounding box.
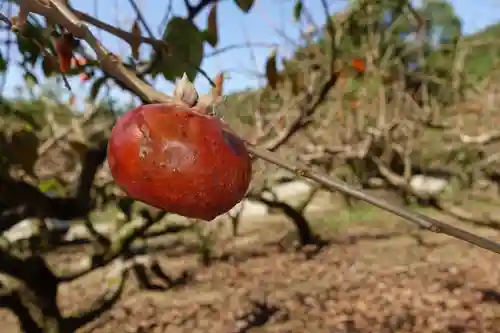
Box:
[108,103,252,221]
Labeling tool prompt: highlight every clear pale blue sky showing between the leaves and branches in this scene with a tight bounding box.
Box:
[0,0,500,104]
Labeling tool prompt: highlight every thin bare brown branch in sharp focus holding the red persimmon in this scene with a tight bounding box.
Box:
[14,0,500,254]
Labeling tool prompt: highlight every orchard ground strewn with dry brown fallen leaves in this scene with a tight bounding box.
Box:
[0,192,500,333]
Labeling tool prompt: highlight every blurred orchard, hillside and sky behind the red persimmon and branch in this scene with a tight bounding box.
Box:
[0,0,500,333]
